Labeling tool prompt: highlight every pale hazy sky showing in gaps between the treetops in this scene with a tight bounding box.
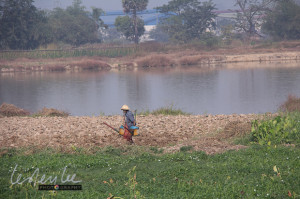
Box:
[34,0,235,11]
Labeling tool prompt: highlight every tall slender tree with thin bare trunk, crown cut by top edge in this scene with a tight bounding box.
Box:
[119,0,148,44]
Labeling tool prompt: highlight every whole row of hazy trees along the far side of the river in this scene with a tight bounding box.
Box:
[0,0,300,49]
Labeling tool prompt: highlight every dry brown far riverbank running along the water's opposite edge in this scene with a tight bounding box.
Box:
[0,44,300,73]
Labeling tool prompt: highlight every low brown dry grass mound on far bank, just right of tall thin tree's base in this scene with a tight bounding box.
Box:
[137,55,175,67]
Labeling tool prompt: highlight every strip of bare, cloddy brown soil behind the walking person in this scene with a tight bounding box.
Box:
[0,114,271,154]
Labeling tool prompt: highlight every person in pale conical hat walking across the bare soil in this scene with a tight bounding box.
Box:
[121,104,135,144]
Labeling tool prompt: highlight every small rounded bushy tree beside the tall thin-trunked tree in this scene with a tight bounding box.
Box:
[115,16,145,43]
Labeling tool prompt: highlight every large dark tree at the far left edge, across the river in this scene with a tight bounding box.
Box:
[0,0,51,49]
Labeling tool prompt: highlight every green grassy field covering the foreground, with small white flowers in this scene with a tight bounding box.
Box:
[0,145,300,199]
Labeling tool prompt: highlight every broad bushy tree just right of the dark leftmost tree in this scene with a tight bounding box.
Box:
[49,0,102,46]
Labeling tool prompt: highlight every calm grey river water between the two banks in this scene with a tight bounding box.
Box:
[0,63,300,116]
